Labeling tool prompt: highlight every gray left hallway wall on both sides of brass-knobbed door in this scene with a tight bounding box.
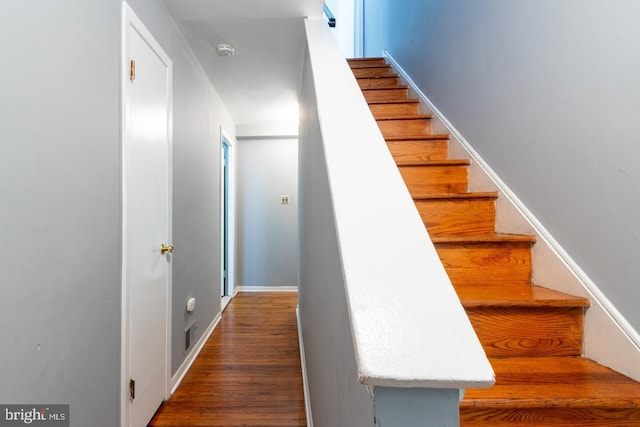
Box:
[0,0,235,427]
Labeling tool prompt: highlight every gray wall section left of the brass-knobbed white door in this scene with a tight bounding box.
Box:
[0,0,121,427]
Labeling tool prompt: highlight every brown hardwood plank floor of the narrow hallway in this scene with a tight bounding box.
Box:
[149,292,307,427]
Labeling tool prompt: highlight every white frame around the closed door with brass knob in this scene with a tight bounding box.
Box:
[120,1,173,427]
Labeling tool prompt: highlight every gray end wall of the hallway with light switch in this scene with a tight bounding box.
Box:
[235,138,298,286]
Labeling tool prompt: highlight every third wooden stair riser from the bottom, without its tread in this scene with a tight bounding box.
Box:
[435,243,531,285]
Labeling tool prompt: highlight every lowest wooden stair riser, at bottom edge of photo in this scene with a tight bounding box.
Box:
[460,407,640,427]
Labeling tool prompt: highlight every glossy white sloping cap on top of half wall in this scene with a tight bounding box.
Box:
[305,18,494,388]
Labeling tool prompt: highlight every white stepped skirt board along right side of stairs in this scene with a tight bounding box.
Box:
[384,51,640,381]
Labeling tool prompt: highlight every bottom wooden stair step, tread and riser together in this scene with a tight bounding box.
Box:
[460,357,640,427]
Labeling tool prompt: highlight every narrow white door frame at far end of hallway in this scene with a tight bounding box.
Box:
[220,126,236,311]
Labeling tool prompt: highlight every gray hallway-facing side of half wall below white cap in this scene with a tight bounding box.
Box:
[298,41,374,427]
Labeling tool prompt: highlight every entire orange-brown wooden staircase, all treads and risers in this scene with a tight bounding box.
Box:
[349,58,640,427]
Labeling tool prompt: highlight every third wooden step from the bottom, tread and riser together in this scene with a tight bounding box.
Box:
[431,233,535,285]
